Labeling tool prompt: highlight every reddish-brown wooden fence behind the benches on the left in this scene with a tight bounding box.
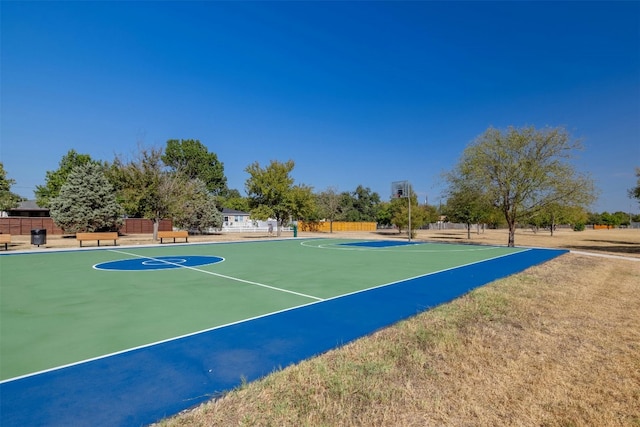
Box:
[0,217,173,236]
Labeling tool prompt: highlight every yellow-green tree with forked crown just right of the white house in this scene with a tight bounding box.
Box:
[245,160,313,236]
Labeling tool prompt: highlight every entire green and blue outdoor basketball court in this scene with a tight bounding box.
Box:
[0,239,566,426]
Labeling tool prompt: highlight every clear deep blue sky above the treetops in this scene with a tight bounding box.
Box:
[0,1,640,212]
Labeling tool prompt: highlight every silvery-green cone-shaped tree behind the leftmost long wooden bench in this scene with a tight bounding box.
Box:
[50,163,123,233]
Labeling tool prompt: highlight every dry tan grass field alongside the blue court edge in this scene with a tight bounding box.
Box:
[160,230,640,427]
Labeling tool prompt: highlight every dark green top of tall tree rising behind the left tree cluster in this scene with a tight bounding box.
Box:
[162,139,227,195]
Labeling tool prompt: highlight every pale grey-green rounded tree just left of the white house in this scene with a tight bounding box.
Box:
[171,178,222,233]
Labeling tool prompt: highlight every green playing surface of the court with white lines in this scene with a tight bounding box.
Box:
[0,239,523,380]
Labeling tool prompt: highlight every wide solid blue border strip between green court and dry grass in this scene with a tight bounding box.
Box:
[0,249,568,426]
